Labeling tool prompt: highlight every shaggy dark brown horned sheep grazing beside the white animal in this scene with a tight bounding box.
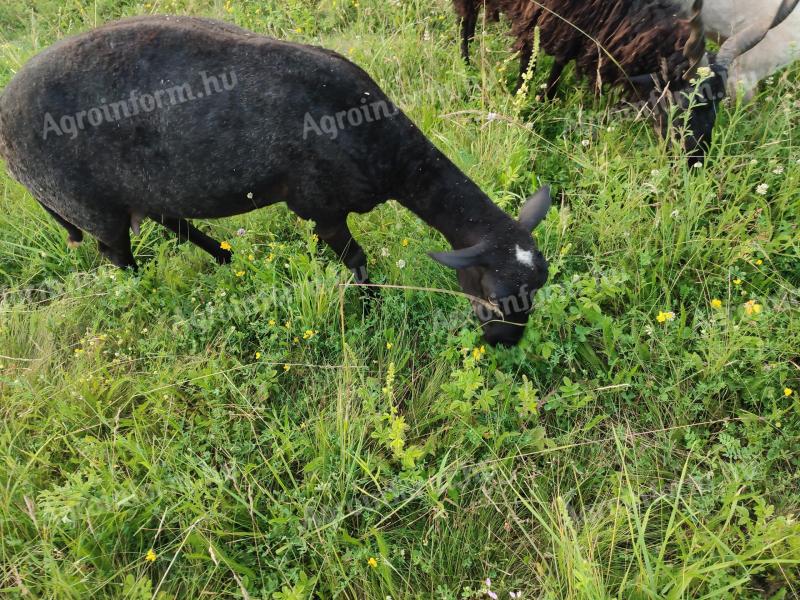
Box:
[454,0,797,163]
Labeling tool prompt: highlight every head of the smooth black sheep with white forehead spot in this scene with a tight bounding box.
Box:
[430,187,552,346]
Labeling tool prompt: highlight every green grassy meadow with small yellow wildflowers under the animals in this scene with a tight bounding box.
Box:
[0,0,800,600]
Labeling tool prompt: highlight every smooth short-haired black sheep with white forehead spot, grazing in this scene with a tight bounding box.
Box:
[0,16,550,344]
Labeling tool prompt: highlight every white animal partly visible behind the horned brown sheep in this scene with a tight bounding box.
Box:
[681,0,800,100]
